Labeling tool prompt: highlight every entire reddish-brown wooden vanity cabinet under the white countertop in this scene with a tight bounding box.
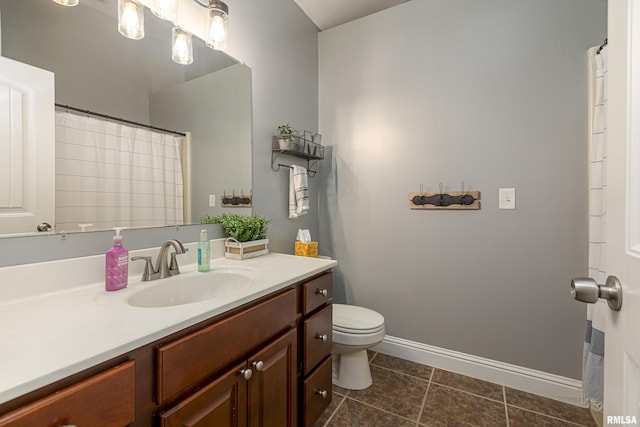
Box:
[0,272,332,427]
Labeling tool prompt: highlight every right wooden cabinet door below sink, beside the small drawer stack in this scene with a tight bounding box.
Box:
[249,329,297,427]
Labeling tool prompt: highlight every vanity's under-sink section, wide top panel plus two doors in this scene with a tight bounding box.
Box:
[157,289,297,427]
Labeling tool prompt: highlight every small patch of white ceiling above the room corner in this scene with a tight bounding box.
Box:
[294,0,408,31]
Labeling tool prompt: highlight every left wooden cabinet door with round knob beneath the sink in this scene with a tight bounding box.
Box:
[160,363,247,427]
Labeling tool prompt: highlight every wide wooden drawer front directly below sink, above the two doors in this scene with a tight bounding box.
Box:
[157,289,297,403]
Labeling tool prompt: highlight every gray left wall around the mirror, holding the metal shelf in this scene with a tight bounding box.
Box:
[0,0,318,267]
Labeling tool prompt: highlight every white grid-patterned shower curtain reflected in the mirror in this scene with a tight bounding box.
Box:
[56,111,184,231]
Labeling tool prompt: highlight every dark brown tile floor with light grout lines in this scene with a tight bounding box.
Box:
[313,353,597,427]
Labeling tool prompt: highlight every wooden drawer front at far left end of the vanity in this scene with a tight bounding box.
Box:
[0,360,135,427]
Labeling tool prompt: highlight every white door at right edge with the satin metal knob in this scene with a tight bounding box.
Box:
[604,0,640,425]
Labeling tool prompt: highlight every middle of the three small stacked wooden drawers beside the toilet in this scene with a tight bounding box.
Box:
[303,305,333,375]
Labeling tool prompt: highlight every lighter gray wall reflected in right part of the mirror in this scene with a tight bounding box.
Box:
[150,64,251,222]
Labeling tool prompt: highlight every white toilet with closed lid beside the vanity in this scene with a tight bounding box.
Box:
[331,304,385,390]
